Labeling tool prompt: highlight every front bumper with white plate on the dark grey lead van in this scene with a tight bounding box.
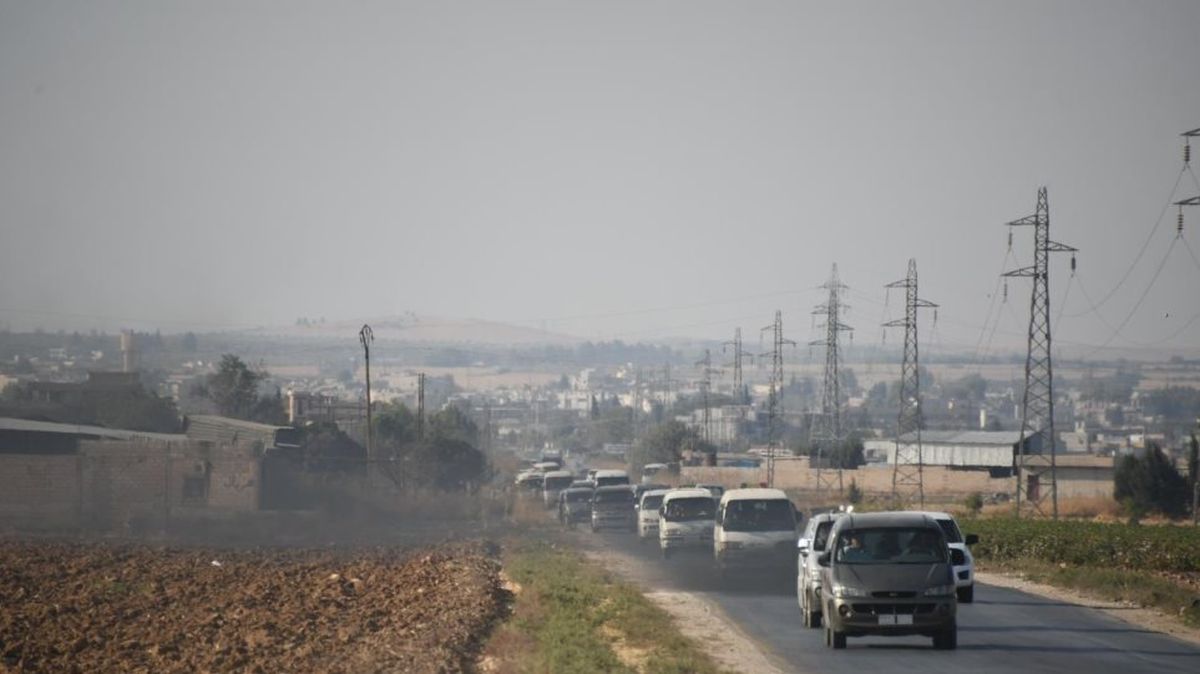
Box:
[823,596,956,636]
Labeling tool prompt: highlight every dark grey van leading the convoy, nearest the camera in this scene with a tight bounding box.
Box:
[817,512,958,650]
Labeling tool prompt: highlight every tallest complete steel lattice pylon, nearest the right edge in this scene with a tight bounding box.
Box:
[1004,187,1076,519]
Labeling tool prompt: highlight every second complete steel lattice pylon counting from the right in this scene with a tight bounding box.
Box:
[883,259,937,508]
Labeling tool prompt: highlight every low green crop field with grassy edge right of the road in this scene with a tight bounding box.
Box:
[960,518,1200,627]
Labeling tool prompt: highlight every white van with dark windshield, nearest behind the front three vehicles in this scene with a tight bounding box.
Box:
[713,489,797,577]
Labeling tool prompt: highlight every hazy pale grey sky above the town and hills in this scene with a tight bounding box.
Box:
[0,0,1200,353]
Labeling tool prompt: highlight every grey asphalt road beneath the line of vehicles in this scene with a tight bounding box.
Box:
[583,534,1200,674]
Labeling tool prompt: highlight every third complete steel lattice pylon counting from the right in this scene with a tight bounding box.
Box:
[809,264,853,492]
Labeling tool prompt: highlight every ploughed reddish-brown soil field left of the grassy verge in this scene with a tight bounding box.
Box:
[0,541,504,673]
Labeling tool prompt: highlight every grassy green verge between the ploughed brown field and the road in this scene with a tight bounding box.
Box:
[484,541,721,674]
